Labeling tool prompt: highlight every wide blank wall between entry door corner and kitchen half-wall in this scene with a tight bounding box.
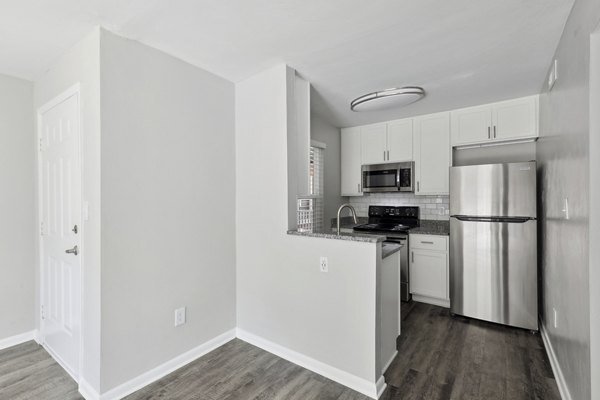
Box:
[101,31,237,392]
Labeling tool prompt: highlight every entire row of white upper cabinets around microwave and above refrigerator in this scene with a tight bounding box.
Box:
[342,95,539,196]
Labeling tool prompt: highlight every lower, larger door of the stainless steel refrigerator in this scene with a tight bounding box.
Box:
[450,217,538,330]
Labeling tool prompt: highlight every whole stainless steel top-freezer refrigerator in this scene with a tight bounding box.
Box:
[450,161,538,330]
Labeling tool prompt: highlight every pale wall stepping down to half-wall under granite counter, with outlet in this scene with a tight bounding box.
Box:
[236,65,377,396]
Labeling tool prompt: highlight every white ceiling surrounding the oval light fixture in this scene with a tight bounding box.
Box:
[0,0,574,126]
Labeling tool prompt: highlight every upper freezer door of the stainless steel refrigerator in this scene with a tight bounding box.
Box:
[450,161,536,218]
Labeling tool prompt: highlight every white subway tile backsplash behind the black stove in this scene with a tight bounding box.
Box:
[349,193,450,221]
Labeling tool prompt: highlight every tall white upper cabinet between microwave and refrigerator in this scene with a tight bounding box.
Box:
[413,112,450,195]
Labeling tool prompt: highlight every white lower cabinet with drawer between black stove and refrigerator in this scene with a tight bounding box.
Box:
[409,234,450,307]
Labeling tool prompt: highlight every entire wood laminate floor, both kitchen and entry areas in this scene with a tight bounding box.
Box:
[0,303,560,400]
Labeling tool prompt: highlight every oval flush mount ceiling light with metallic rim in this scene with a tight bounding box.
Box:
[350,86,425,111]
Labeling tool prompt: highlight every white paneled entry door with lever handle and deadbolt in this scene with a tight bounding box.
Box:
[39,93,81,378]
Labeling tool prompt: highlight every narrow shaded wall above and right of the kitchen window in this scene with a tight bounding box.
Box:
[310,113,348,228]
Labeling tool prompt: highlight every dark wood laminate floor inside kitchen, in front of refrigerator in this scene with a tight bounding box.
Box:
[385,302,560,400]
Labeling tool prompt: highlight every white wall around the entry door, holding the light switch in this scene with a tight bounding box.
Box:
[32,29,100,390]
